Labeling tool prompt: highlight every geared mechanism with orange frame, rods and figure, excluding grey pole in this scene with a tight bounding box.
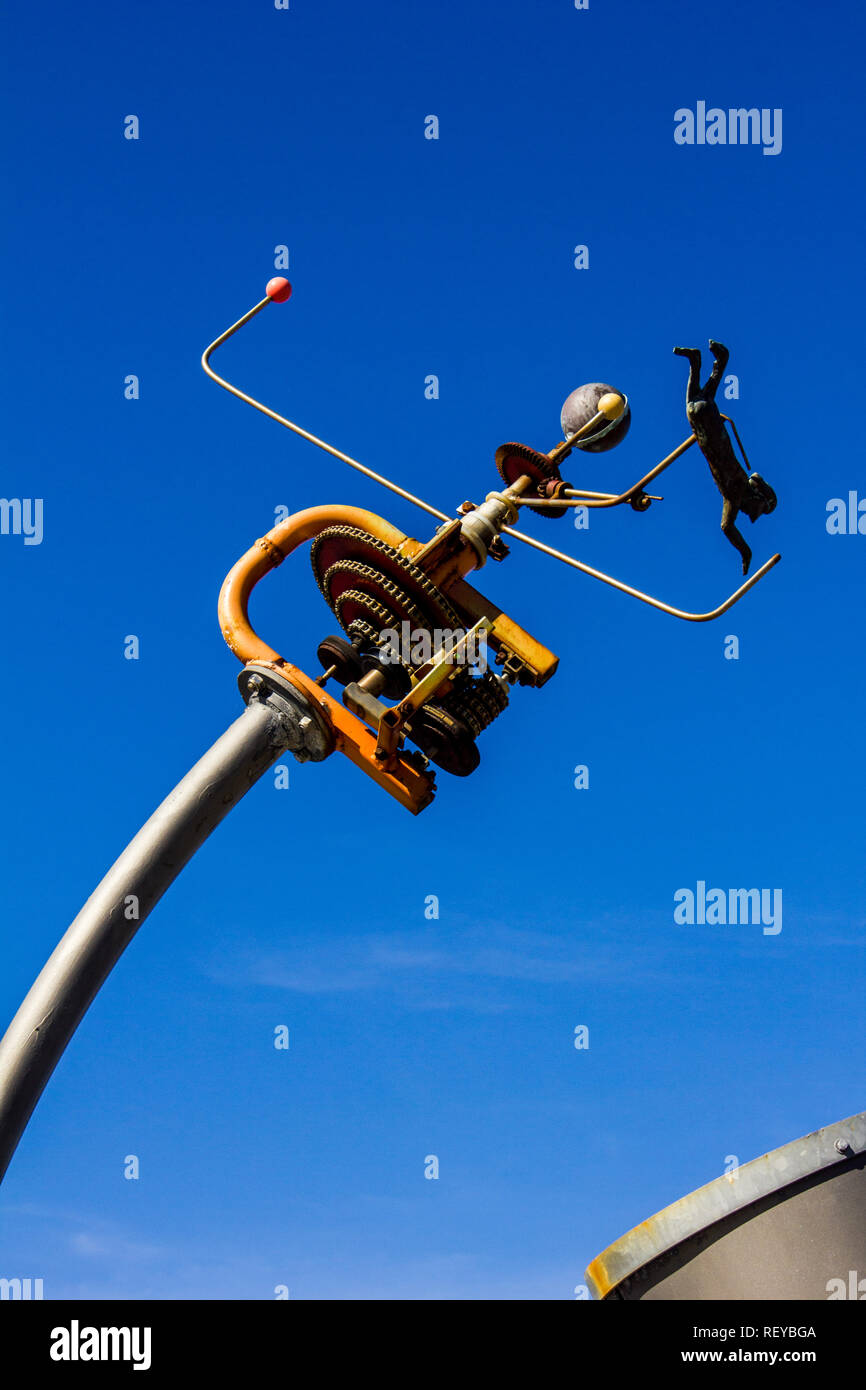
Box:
[208,278,780,813]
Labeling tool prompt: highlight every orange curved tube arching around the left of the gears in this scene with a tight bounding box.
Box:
[218,505,409,663]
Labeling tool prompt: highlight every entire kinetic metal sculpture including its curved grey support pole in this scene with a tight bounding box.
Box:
[0,278,780,1177]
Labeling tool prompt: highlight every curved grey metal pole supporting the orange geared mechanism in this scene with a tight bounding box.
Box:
[0,699,291,1182]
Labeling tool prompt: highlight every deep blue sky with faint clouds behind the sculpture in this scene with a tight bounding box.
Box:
[0,0,866,1298]
